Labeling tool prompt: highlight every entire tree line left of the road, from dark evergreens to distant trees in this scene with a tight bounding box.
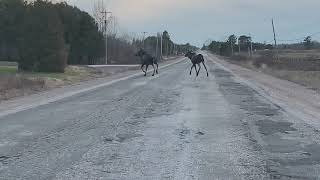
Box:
[0,0,196,72]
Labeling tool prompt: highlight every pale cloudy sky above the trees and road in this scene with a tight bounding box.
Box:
[65,0,320,46]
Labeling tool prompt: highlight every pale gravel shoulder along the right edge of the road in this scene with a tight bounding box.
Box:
[208,53,320,128]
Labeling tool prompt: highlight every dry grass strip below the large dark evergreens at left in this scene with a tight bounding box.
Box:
[0,66,99,101]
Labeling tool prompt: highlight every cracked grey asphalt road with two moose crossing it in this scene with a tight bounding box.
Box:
[0,53,320,180]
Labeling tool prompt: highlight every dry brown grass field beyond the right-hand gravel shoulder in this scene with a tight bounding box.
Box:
[228,50,320,90]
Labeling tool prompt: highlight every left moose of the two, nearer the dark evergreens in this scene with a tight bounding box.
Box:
[136,49,159,76]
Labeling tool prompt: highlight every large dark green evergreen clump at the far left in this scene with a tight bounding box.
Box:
[0,0,105,72]
